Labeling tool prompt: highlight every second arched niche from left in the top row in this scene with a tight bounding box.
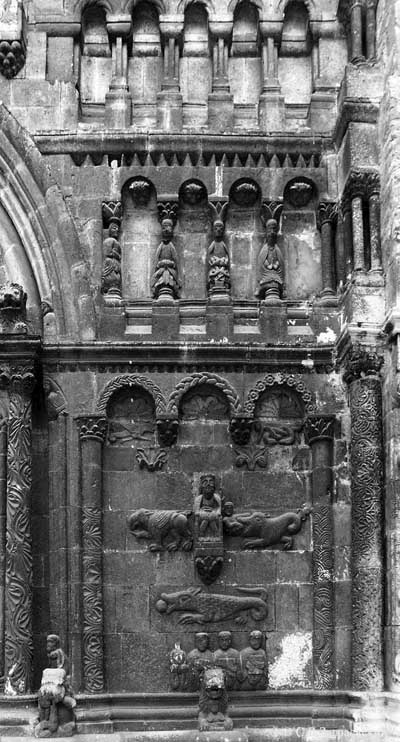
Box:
[128,2,162,126]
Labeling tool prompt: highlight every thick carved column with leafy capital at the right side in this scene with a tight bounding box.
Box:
[344,346,383,691]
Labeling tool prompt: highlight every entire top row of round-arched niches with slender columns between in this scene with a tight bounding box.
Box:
[75,0,347,131]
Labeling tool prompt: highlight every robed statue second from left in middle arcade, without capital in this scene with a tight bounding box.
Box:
[151,218,181,301]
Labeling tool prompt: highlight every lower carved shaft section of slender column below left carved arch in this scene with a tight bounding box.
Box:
[82,506,104,693]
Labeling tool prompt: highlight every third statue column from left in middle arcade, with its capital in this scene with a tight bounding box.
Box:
[207,202,231,303]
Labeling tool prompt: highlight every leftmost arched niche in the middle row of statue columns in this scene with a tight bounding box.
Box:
[121,177,161,300]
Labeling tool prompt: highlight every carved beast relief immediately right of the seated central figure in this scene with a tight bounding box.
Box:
[223,503,312,549]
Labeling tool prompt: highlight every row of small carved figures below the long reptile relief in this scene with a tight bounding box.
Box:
[169,630,268,692]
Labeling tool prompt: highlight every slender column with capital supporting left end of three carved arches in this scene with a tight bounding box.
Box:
[78,415,107,693]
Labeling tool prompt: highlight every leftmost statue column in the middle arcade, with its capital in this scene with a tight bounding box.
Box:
[101,201,122,299]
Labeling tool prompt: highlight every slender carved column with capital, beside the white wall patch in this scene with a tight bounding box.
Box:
[304,415,335,690]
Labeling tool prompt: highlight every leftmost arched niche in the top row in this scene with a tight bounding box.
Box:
[79,5,112,118]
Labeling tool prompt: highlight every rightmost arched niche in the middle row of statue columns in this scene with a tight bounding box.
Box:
[281,178,322,301]
